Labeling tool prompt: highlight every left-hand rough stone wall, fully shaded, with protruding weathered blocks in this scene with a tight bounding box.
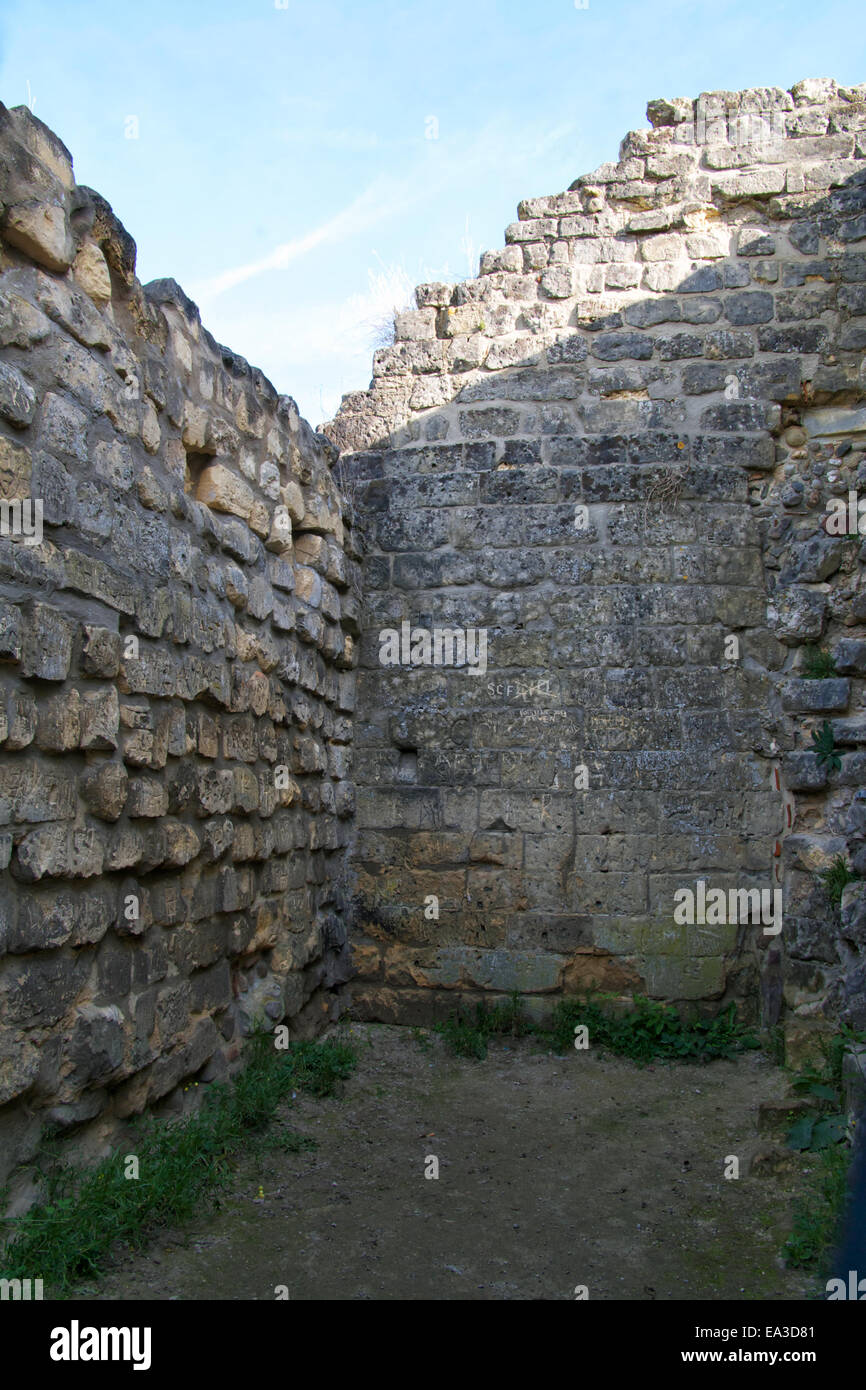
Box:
[0,107,359,1201]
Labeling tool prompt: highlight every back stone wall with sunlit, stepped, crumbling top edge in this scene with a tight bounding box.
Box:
[325,81,866,1051]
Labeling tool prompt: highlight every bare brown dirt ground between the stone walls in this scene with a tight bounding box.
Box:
[75,1023,809,1300]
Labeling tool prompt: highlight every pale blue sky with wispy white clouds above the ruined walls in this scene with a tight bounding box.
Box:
[0,0,866,424]
